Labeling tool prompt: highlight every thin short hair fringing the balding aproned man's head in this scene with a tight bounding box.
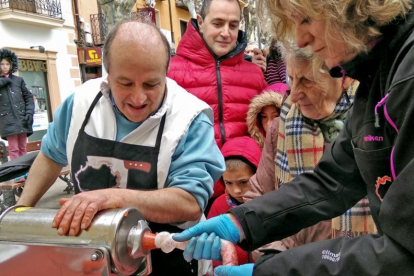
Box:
[102,19,171,73]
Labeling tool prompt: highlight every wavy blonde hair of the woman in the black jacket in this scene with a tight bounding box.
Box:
[261,0,412,53]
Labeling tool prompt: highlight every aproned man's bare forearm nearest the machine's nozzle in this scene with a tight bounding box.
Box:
[111,188,201,223]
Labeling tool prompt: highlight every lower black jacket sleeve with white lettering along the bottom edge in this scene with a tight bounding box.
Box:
[253,235,414,276]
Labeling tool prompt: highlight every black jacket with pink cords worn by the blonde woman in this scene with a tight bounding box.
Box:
[230,7,414,275]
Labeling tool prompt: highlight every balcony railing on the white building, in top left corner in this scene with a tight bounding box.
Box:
[0,0,62,19]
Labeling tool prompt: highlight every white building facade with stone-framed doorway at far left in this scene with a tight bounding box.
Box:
[0,0,81,141]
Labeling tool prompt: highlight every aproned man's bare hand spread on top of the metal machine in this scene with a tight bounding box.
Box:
[52,189,121,236]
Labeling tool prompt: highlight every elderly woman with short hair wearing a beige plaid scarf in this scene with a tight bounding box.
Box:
[244,45,376,256]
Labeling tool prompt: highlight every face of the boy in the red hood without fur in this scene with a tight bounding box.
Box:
[223,168,253,203]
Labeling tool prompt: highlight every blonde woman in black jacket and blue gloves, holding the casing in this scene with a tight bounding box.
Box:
[175,0,414,275]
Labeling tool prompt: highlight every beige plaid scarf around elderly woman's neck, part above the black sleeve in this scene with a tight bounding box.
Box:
[275,81,359,187]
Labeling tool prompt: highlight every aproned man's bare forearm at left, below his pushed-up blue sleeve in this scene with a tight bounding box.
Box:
[17,152,62,206]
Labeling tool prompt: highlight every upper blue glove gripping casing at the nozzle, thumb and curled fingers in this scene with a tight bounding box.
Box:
[173,215,240,262]
